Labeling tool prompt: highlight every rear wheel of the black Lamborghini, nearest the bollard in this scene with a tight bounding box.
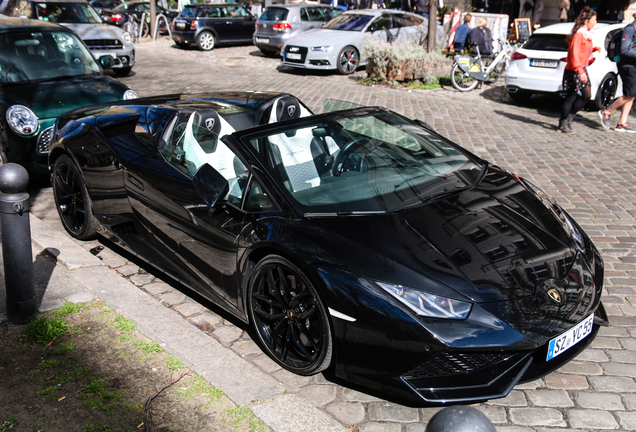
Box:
[53,155,97,240]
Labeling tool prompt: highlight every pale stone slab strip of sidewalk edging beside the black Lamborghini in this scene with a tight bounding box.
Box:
[0,214,347,432]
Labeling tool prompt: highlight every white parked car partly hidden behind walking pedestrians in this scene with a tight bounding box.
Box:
[506,23,625,109]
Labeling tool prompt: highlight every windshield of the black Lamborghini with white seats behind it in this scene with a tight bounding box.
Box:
[243,108,482,215]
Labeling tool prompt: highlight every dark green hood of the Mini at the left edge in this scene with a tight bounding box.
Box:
[0,76,128,119]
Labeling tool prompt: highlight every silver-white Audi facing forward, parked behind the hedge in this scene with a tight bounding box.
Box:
[282,9,428,75]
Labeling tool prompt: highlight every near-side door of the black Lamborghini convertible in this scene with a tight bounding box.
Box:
[124,112,248,313]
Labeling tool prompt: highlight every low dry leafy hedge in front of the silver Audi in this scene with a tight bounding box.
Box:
[364,39,452,84]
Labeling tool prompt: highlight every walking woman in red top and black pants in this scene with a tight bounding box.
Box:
[558,6,601,134]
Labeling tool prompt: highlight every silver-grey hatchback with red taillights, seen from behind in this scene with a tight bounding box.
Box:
[253,3,342,56]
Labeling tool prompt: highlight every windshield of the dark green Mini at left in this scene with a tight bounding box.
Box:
[0,31,101,85]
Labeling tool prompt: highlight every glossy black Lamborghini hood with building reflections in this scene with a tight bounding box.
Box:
[308,170,576,303]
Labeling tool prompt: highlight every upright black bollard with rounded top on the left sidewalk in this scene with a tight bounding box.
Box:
[0,163,38,324]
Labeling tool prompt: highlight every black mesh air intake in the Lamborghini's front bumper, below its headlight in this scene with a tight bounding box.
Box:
[403,351,516,379]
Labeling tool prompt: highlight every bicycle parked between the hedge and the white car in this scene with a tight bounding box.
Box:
[451,39,512,92]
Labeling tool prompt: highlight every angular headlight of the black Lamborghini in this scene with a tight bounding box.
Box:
[376,282,473,319]
